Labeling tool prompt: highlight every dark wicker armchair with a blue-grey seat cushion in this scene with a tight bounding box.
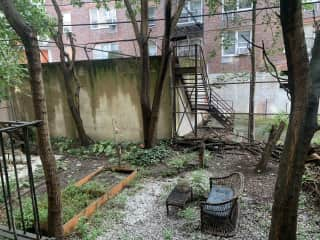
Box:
[200,172,244,237]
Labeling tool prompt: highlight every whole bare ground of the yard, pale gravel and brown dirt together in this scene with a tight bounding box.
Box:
[1,131,320,240]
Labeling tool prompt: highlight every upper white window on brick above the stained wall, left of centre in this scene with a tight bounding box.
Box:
[89,8,117,29]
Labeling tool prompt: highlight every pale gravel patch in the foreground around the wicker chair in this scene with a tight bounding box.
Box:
[98,177,320,240]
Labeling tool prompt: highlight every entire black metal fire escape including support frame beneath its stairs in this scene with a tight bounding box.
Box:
[172,45,234,138]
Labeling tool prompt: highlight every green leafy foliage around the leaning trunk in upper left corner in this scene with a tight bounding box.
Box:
[0,0,53,100]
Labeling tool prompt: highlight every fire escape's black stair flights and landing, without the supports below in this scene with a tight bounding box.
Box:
[174,45,234,130]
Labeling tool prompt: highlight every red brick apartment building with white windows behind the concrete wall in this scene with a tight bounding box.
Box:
[42,0,320,74]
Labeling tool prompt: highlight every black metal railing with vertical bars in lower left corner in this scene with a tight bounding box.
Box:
[0,121,52,240]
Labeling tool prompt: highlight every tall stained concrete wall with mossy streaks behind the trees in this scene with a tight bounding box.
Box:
[15,58,171,141]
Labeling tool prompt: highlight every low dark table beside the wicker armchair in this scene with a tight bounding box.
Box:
[166,187,193,215]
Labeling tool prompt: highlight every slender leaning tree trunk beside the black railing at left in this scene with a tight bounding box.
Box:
[0,0,63,239]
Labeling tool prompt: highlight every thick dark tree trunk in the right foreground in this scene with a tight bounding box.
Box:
[269,0,319,240]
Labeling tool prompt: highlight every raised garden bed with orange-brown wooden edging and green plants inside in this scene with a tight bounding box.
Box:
[16,167,137,236]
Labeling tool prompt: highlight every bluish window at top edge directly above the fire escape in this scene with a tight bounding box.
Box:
[178,0,202,24]
